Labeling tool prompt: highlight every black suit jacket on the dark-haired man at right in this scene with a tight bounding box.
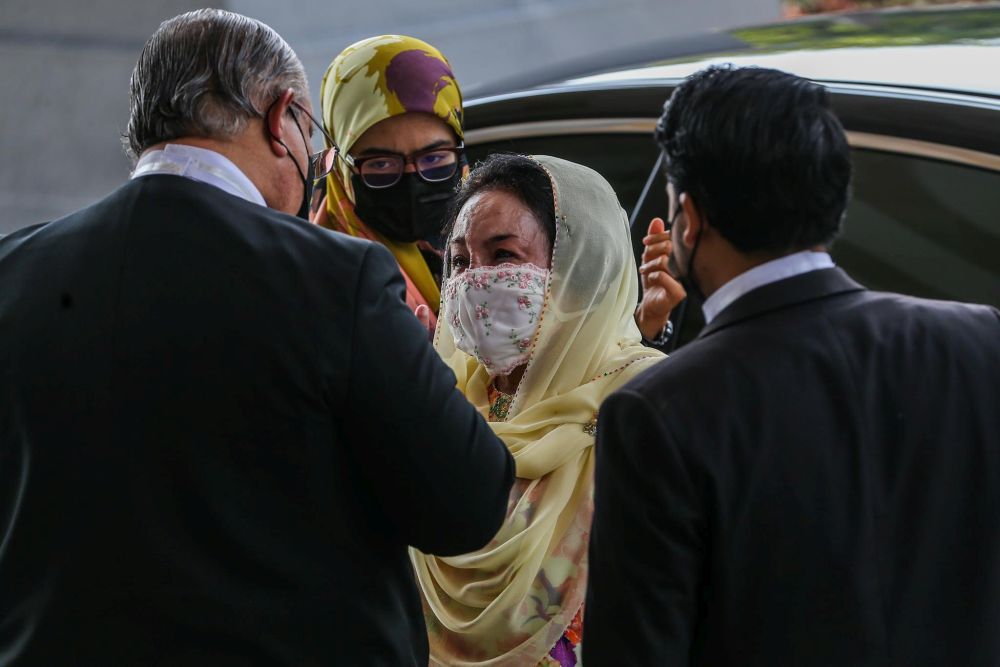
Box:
[584,269,1000,667]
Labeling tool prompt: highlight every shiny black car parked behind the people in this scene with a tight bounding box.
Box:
[466,4,1000,344]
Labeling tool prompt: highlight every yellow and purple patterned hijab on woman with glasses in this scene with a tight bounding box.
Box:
[314,35,463,313]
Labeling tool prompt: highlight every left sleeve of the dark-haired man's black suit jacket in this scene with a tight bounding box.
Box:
[583,390,704,667]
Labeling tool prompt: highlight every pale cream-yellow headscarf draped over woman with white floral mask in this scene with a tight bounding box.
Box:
[411,156,662,665]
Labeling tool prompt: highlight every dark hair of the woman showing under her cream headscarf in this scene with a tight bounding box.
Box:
[445,153,556,266]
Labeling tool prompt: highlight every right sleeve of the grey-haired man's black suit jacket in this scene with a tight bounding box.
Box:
[347,245,514,556]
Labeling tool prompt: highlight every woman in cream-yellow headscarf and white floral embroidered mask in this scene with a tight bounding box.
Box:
[411,155,676,666]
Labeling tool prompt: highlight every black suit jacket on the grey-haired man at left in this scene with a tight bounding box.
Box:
[0,176,513,666]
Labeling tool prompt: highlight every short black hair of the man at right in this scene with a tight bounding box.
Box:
[656,66,851,254]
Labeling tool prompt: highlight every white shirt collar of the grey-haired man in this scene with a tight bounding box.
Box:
[132,144,267,206]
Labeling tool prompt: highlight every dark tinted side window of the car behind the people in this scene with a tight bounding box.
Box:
[469,134,1000,345]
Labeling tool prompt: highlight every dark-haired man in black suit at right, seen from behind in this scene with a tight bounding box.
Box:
[584,67,1000,667]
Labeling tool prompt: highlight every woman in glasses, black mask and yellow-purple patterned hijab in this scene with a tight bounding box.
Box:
[312,35,467,324]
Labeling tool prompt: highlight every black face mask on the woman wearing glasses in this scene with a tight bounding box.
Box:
[351,169,462,244]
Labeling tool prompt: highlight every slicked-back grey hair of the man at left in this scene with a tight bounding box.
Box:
[122,9,309,160]
